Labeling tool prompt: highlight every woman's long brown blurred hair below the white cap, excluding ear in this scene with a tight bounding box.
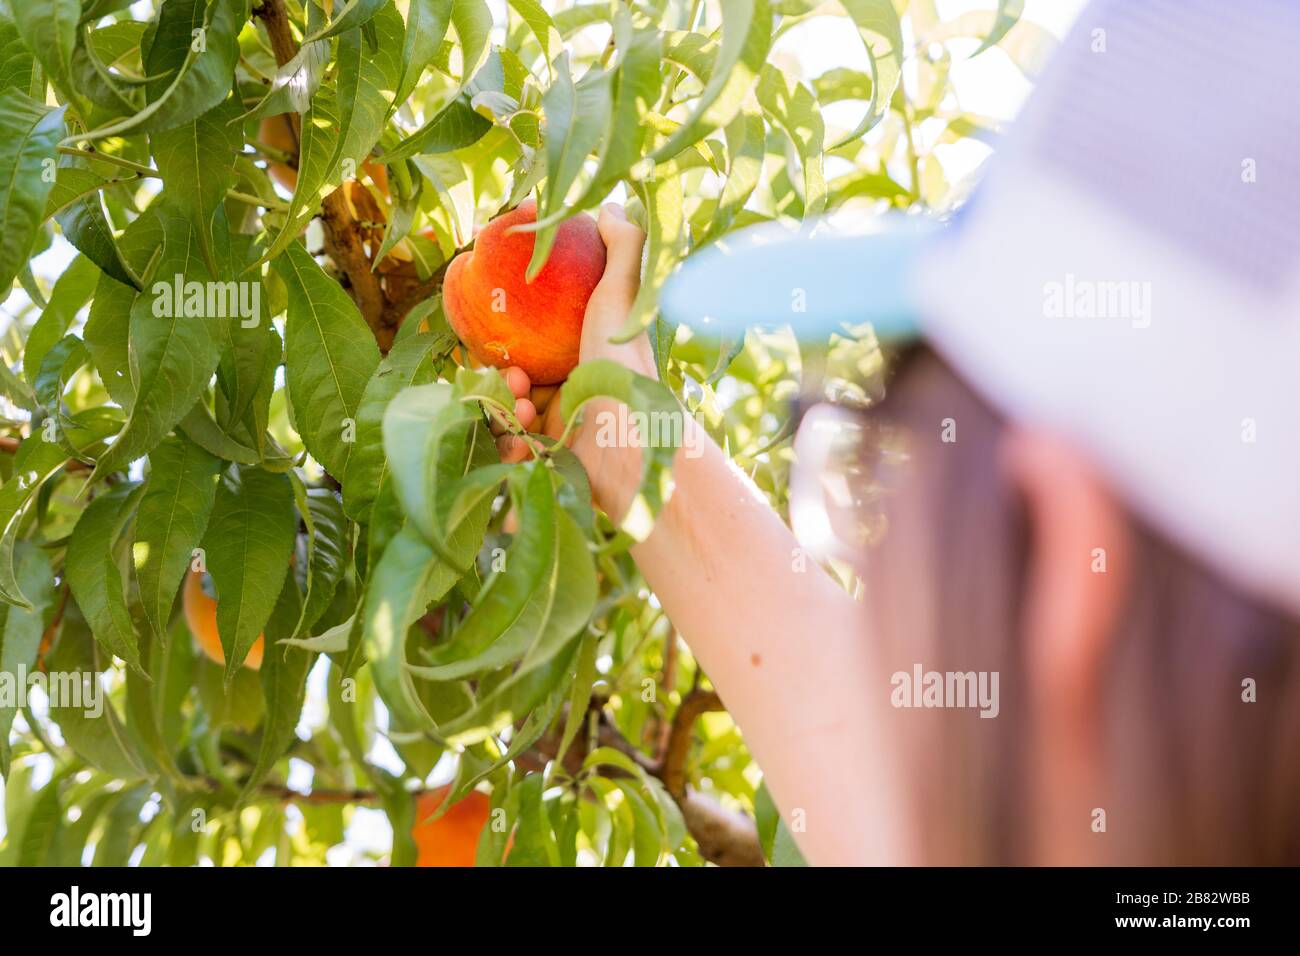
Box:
[861,349,1300,865]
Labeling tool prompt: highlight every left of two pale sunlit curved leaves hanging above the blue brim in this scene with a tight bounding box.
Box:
[653,0,764,163]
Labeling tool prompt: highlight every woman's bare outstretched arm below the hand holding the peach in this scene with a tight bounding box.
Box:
[588,423,888,864]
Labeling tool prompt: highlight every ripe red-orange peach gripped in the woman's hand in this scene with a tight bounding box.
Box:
[442,200,605,385]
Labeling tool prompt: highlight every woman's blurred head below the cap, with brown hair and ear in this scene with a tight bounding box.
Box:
[831,349,1300,865]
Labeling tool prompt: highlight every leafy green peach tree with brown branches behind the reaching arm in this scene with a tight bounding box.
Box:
[0,0,1041,865]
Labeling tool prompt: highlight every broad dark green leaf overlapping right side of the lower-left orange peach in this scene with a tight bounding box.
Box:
[203,466,298,684]
